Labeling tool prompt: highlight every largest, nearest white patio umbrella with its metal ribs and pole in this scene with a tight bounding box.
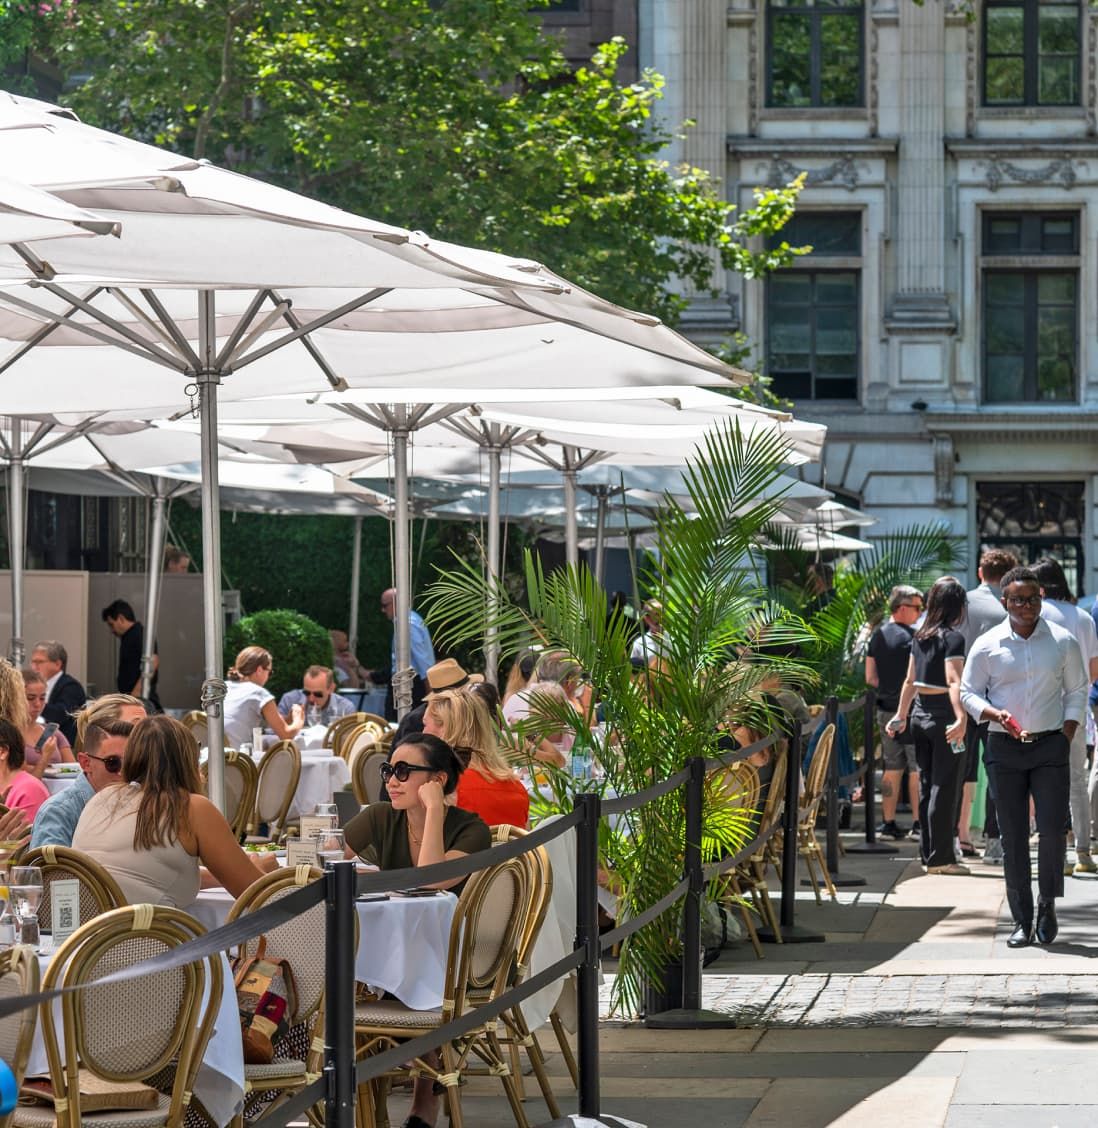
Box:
[0,96,736,785]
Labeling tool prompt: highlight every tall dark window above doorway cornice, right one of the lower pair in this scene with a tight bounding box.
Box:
[983,212,1079,404]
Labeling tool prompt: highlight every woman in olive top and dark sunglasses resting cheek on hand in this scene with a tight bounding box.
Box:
[343,733,492,1128]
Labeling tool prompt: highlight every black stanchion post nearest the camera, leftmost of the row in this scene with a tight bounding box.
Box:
[324,862,355,1128]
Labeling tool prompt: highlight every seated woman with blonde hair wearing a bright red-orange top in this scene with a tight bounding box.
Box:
[423,689,530,827]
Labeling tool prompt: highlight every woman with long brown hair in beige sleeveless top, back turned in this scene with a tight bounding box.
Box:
[72,715,278,909]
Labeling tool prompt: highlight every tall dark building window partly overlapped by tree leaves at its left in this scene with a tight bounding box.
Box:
[766,212,861,400]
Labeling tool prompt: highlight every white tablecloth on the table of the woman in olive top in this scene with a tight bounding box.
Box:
[190,889,457,1011]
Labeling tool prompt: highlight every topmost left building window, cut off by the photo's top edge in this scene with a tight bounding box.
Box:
[766,0,864,107]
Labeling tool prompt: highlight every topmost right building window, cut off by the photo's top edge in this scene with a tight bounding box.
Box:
[984,0,1081,106]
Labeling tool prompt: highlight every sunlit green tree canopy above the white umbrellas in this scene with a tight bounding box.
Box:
[25,0,797,324]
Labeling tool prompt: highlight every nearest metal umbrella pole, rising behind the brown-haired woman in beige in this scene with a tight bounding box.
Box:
[195,290,226,814]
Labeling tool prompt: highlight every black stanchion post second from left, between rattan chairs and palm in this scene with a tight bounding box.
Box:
[576,792,601,1120]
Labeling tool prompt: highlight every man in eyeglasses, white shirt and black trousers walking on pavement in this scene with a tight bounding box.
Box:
[960,567,1088,948]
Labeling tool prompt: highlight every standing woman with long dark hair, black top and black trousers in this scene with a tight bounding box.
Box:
[888,575,968,875]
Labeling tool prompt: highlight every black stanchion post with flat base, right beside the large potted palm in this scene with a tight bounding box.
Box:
[644,756,736,1030]
